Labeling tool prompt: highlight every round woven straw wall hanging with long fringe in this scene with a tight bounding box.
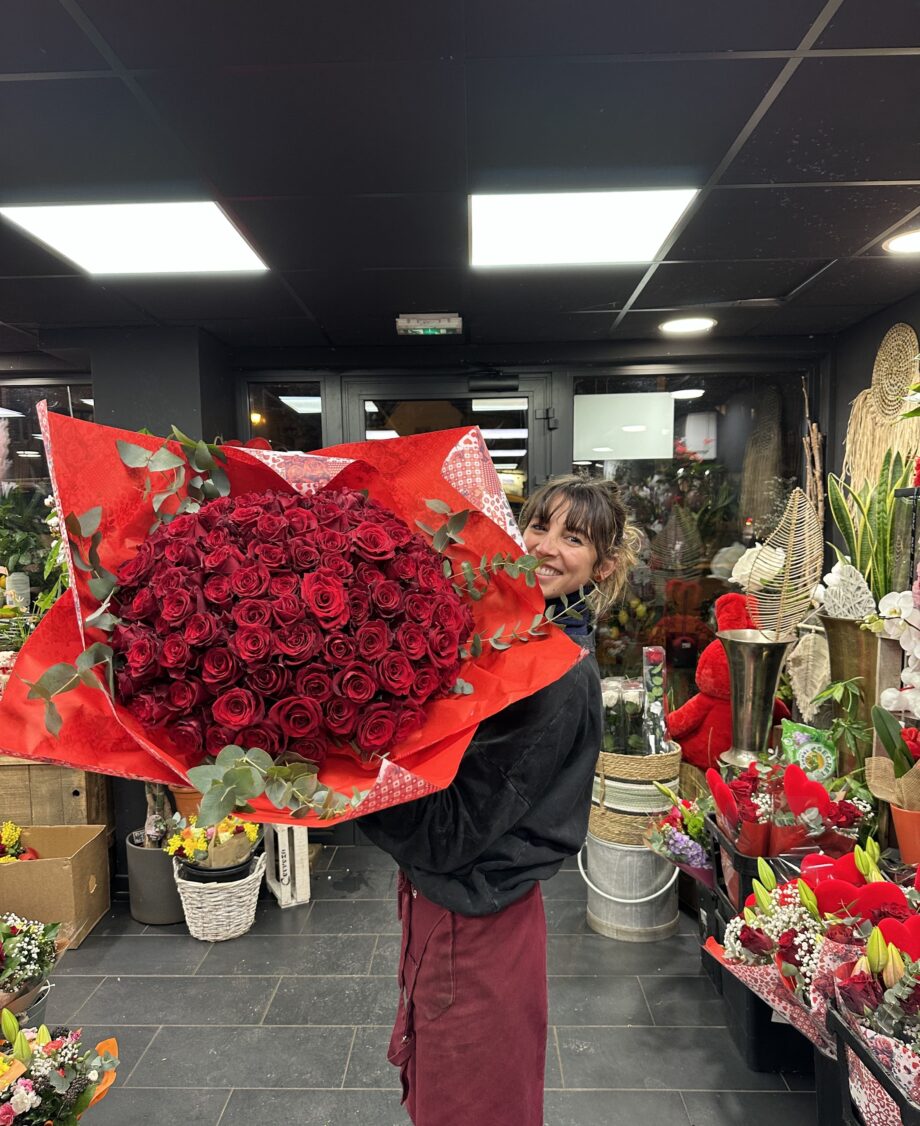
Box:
[841,324,920,489]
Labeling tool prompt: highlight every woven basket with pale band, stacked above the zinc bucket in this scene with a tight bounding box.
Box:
[588,743,680,845]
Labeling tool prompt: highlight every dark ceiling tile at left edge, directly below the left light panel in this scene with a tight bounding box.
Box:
[0,277,150,328]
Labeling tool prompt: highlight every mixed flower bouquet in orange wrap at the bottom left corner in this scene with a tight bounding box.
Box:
[0,1009,118,1126]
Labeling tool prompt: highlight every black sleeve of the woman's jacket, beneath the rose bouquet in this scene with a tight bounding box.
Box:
[358,660,601,873]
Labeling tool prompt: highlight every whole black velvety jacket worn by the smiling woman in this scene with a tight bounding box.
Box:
[359,638,602,915]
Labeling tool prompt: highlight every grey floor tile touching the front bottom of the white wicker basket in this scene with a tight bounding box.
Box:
[199,935,377,976]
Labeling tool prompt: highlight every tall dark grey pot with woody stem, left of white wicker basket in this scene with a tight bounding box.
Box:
[127,783,182,926]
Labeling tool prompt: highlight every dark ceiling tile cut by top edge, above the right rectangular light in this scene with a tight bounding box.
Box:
[466,0,824,57]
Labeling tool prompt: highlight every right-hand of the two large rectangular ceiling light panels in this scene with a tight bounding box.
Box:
[470,188,697,266]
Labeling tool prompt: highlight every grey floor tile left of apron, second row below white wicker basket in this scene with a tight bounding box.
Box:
[262,976,399,1025]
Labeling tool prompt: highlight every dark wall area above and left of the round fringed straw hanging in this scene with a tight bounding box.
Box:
[827,292,920,473]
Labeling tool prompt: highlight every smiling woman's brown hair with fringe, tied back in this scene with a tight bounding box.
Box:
[518,473,641,619]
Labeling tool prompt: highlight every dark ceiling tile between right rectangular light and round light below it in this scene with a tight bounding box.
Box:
[636,259,822,309]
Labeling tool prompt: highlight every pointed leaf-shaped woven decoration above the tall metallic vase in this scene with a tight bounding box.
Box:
[744,489,824,641]
